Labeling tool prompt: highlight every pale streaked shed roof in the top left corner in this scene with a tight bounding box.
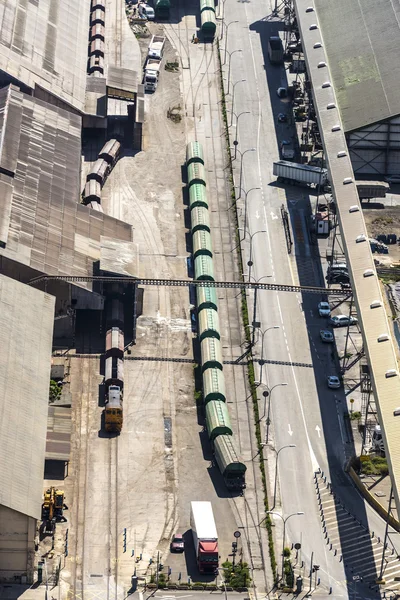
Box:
[0,0,90,111]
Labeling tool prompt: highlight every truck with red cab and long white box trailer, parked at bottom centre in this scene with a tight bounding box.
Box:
[190,502,219,573]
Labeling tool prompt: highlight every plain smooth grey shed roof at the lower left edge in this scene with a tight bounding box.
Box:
[0,275,55,519]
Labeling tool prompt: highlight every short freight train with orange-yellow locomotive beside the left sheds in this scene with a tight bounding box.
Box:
[104,283,124,433]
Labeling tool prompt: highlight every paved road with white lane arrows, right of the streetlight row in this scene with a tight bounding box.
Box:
[221,0,398,597]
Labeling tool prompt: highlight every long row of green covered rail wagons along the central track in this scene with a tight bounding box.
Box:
[186,142,246,491]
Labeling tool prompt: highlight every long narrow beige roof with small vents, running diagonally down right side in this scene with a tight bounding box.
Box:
[295,0,400,511]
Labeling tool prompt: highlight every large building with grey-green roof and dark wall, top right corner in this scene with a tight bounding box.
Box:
[315,0,400,179]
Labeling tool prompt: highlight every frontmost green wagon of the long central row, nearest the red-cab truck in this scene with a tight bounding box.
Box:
[214,435,247,490]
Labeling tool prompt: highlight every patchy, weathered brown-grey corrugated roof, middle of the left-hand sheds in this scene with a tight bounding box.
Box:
[0,86,132,287]
